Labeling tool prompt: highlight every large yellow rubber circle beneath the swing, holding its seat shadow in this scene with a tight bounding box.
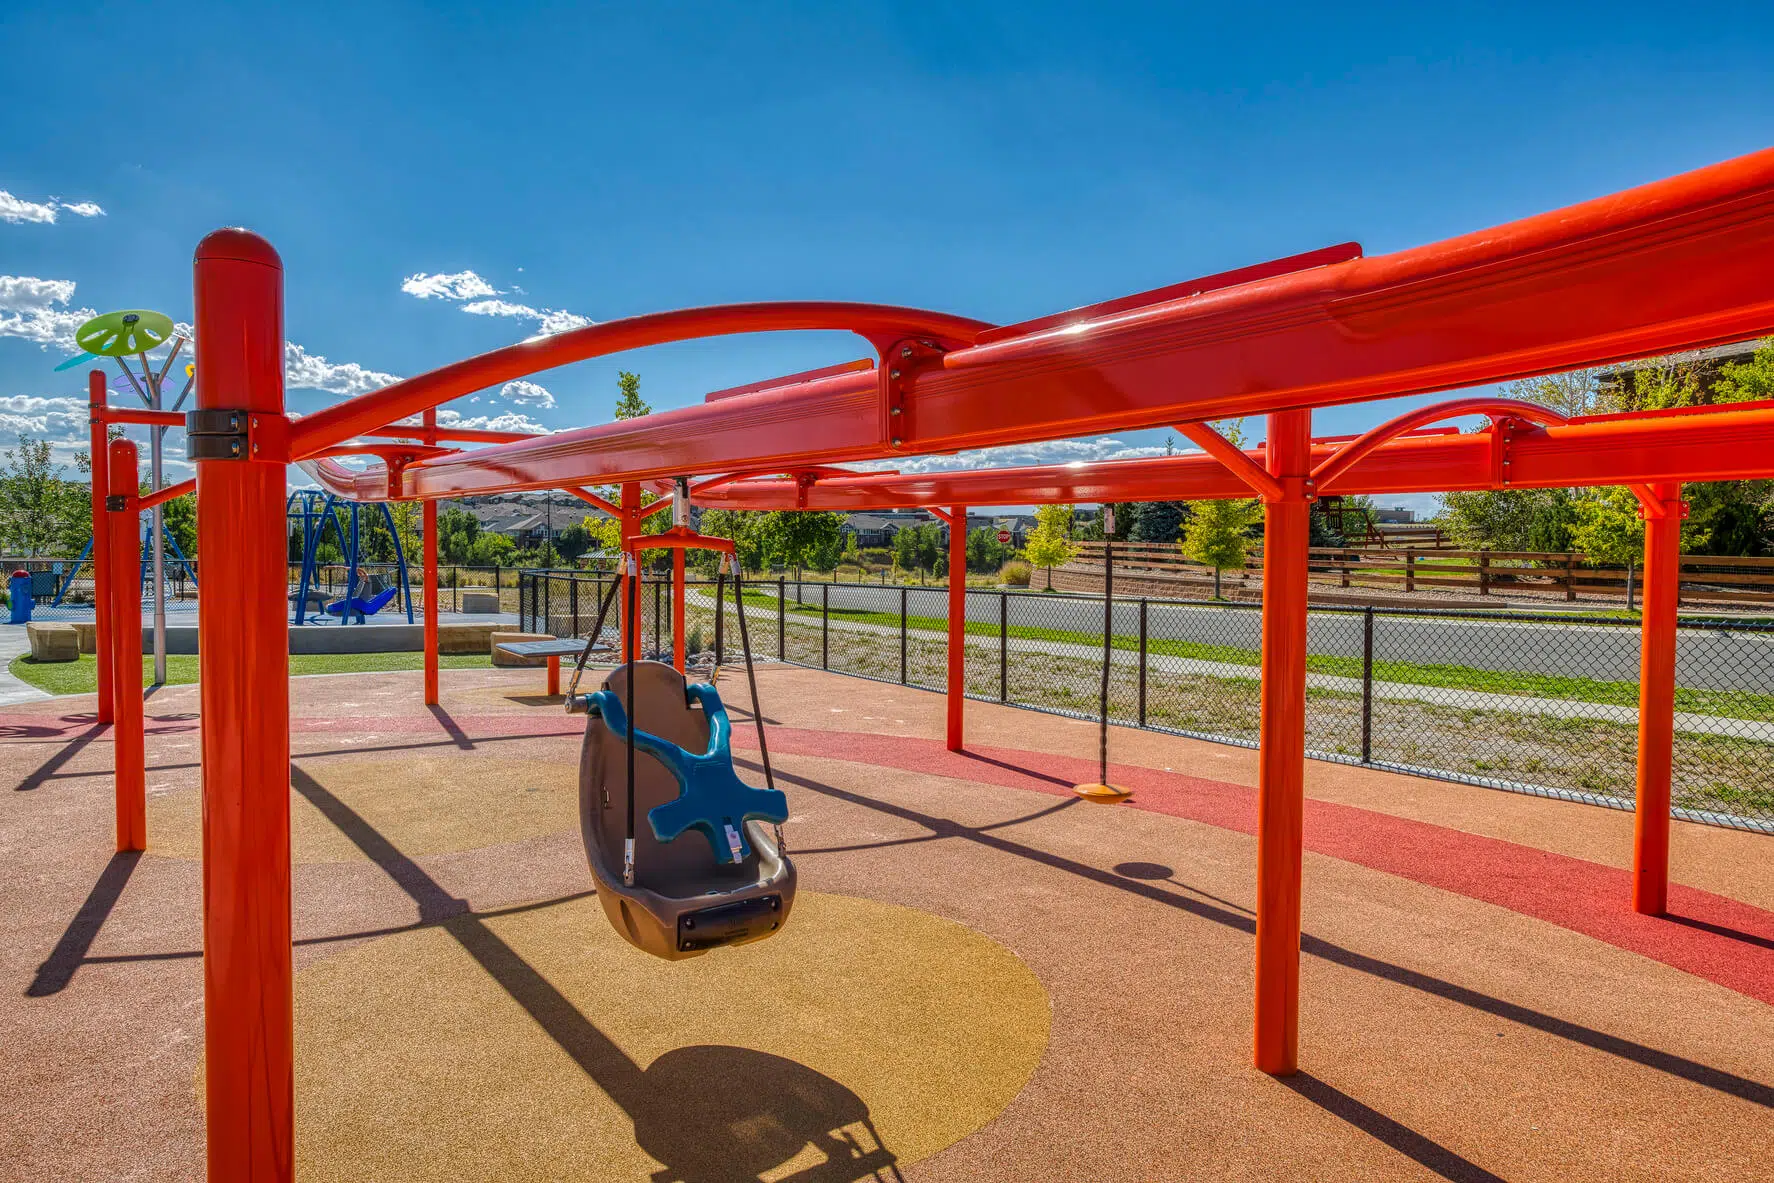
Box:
[282,892,1048,1181]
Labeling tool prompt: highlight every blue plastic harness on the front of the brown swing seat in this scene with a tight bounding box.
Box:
[591,683,788,866]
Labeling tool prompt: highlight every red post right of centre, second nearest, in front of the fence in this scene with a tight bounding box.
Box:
[1252,411,1313,1077]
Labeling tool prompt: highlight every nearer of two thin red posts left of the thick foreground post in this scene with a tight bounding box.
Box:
[105,440,147,850]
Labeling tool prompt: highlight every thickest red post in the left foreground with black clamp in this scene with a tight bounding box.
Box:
[192,231,294,1183]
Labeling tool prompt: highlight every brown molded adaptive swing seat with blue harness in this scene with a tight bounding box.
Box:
[578,662,795,961]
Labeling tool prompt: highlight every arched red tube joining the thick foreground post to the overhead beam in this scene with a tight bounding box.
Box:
[289,300,992,459]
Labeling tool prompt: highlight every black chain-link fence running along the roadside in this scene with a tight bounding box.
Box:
[520,573,1774,832]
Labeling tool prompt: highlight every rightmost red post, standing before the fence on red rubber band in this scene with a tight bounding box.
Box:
[1632,482,1687,915]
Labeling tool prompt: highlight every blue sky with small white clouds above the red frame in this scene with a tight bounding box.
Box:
[0,0,1774,514]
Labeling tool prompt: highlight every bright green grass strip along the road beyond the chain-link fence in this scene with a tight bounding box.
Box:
[713,591,1774,720]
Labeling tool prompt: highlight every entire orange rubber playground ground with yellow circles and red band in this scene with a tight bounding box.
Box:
[0,667,1774,1183]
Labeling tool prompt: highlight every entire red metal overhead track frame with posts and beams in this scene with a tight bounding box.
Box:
[79,149,1774,1179]
